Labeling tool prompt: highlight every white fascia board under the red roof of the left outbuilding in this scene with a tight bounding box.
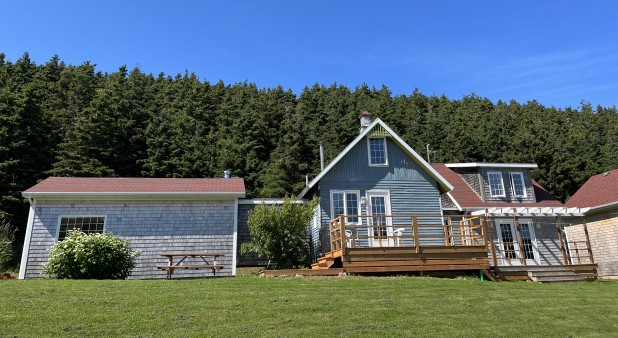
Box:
[22,192,245,200]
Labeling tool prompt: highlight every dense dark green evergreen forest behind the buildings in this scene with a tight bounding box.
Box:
[0,54,618,247]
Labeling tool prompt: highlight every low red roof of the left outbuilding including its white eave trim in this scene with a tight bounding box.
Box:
[22,177,245,198]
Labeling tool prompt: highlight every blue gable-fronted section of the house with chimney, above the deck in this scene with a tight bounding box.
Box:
[299,112,453,257]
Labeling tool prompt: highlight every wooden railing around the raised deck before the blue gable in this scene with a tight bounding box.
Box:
[329,215,487,252]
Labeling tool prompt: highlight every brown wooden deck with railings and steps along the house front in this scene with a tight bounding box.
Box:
[304,215,597,281]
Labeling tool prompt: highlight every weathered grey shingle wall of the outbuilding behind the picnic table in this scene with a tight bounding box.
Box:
[25,200,236,279]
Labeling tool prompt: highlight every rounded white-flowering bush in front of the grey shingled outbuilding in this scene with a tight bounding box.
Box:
[43,230,139,279]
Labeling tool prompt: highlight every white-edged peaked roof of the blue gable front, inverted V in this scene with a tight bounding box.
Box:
[298,118,453,198]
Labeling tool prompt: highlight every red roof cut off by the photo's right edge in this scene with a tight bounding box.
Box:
[565,169,618,208]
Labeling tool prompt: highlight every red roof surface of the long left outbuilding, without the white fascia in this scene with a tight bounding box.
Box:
[24,177,245,193]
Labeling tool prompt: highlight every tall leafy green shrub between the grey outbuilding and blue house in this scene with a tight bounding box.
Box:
[241,198,318,269]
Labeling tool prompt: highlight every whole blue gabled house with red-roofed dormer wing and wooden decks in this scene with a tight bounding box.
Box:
[299,112,596,281]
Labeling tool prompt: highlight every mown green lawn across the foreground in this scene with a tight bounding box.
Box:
[0,276,618,337]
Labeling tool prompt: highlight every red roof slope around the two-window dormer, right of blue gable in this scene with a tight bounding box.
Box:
[432,163,562,209]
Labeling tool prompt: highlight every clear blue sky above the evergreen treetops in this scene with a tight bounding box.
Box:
[0,0,618,108]
